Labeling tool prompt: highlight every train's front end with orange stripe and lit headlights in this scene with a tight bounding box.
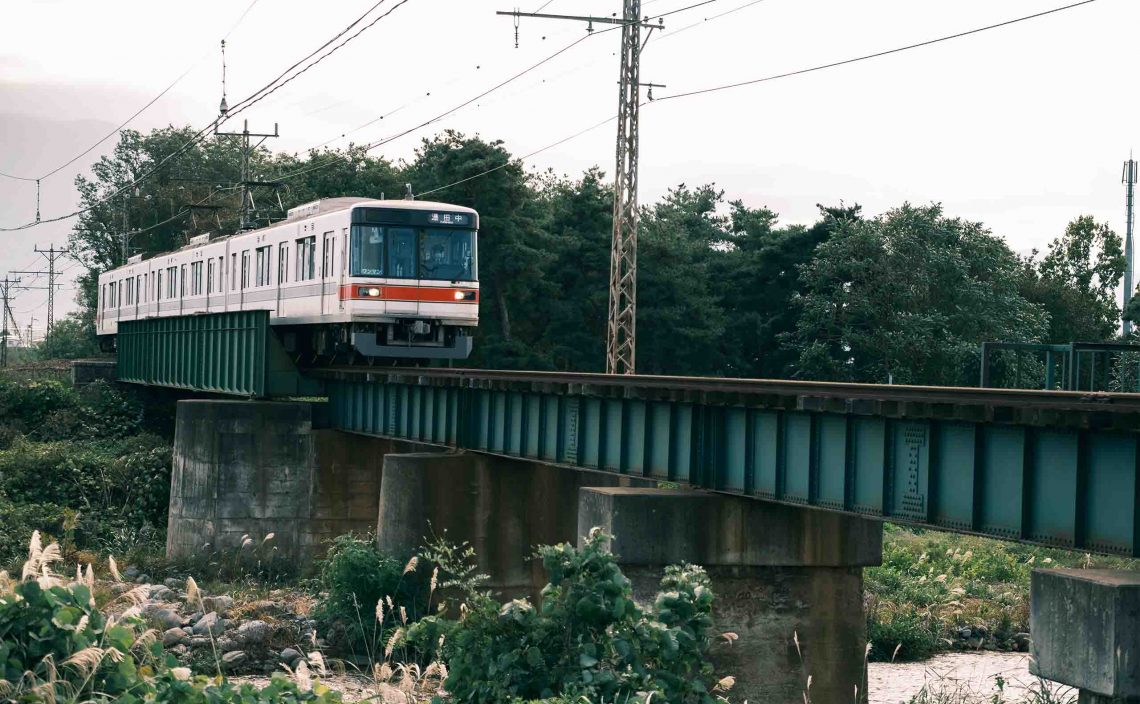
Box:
[341,200,479,360]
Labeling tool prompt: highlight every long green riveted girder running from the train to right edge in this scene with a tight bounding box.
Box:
[320,370,1140,556]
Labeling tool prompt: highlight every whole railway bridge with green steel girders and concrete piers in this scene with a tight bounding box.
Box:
[107,312,1140,702]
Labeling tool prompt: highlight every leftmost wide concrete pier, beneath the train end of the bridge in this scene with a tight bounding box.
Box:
[166,400,417,572]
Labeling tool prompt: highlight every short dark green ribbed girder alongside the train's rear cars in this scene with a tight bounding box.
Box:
[115,311,323,398]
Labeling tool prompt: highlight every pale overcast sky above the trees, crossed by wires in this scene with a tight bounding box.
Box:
[0,0,1140,336]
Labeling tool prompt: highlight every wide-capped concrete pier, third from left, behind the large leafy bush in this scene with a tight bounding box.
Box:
[578,489,882,704]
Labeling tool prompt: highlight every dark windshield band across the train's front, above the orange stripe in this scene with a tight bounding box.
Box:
[351,224,479,281]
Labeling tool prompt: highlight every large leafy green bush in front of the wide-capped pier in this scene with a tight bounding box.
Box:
[430,531,714,703]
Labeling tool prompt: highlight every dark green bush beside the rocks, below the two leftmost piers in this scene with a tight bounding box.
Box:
[314,534,425,660]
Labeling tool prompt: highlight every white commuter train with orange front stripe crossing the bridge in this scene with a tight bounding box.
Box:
[96,197,479,359]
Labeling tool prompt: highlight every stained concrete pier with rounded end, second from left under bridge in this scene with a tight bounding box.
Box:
[376,452,630,599]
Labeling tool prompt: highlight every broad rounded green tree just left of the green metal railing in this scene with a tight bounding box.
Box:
[788,204,1047,385]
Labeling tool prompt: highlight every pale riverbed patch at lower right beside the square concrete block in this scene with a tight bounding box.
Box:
[868,652,1076,704]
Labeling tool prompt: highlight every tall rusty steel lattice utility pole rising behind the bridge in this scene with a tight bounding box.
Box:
[497,0,665,374]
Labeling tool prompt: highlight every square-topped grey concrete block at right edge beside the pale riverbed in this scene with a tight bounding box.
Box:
[1029,570,1140,704]
